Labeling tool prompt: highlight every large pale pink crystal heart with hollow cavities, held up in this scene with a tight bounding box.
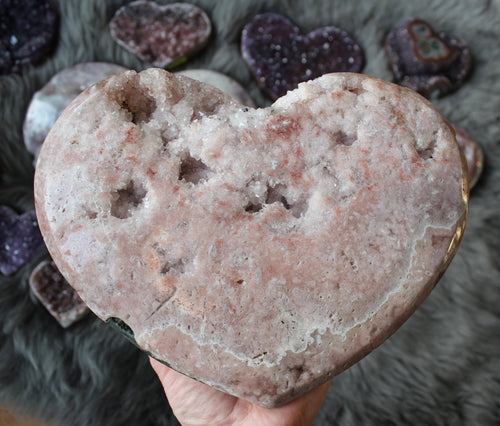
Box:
[35,69,468,407]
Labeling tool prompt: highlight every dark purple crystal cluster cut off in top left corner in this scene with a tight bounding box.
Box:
[0,0,58,74]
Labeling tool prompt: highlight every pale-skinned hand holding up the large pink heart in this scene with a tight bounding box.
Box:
[150,358,330,426]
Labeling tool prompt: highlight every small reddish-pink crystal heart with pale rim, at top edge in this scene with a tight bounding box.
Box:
[109,0,212,67]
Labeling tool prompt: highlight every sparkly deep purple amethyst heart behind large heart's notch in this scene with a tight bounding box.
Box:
[241,13,364,100]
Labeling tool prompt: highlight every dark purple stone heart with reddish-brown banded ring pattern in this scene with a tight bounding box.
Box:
[385,19,472,98]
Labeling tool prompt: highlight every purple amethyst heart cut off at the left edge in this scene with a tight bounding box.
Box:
[0,206,44,275]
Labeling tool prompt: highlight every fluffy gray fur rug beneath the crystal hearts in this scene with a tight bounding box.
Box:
[0,0,500,426]
